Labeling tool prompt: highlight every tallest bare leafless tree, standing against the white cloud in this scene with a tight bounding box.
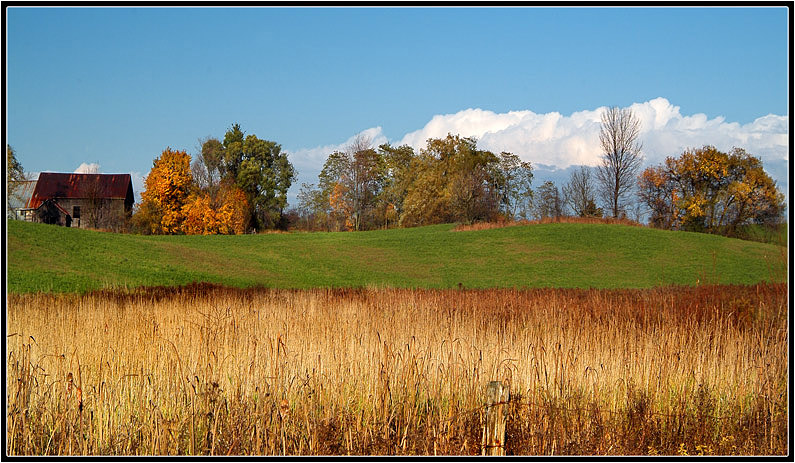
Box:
[596,106,643,218]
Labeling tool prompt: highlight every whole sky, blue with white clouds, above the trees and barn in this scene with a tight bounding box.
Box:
[6,7,790,207]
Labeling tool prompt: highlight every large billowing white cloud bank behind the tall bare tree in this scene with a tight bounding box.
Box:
[398,98,789,169]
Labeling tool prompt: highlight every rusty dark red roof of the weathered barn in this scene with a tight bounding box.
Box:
[28,172,133,209]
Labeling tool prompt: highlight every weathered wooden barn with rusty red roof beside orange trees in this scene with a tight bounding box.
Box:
[22,172,135,230]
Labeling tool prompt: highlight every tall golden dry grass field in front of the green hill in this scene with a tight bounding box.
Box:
[5,284,789,455]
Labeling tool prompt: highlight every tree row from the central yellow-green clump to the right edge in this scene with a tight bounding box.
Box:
[288,107,785,239]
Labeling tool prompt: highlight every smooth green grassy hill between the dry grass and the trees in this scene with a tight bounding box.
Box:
[7,221,787,293]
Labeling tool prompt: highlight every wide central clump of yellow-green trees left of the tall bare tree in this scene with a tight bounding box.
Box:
[296,135,533,231]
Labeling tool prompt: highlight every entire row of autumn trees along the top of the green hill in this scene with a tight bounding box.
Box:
[6,107,786,239]
